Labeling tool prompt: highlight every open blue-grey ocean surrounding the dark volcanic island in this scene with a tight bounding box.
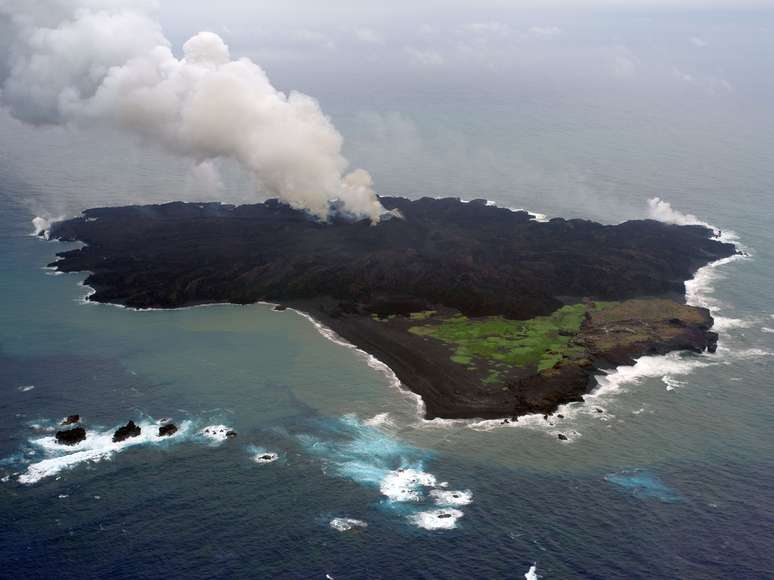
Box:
[0,78,774,580]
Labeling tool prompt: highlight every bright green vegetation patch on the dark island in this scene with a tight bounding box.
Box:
[409,302,611,372]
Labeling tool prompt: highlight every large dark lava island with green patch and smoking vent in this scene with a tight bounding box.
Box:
[50,197,737,419]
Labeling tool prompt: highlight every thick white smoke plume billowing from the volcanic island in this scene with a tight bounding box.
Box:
[0,0,384,222]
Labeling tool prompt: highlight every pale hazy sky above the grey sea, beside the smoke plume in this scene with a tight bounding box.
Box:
[153,0,774,101]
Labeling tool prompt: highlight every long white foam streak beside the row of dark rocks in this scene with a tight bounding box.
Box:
[18,421,190,485]
